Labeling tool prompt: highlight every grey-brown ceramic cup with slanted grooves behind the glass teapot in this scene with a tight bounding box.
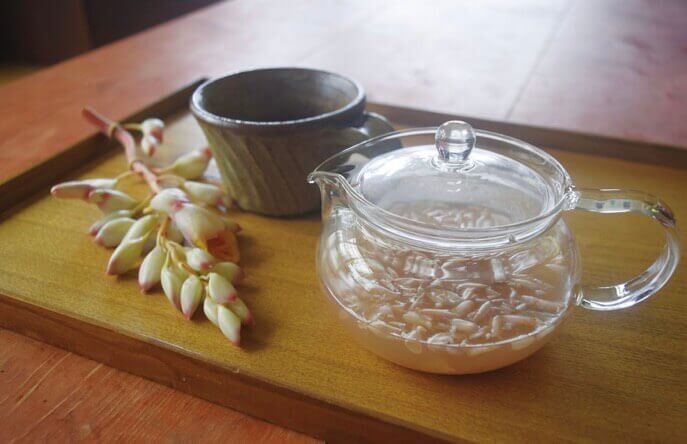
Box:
[191,68,393,216]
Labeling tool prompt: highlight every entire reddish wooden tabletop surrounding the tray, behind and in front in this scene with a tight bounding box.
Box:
[0,0,687,442]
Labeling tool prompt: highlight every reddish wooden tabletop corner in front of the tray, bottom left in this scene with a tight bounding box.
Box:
[0,330,315,443]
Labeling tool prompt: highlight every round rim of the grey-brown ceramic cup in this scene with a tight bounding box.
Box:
[190,67,366,133]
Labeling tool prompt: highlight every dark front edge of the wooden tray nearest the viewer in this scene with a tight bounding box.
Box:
[0,294,455,443]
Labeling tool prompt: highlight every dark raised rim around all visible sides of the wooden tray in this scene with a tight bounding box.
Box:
[0,85,687,442]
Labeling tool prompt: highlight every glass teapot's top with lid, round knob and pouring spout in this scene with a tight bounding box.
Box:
[316,121,571,248]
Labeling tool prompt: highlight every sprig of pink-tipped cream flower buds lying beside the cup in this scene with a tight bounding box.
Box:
[51,108,253,346]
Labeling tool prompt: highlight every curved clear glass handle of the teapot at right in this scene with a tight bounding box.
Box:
[573,188,681,310]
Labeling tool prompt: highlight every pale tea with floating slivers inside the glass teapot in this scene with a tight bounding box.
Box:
[320,203,574,373]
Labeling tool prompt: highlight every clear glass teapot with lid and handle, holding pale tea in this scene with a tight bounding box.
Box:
[308,121,680,374]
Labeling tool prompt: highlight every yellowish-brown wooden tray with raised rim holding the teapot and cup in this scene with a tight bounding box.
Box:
[0,85,687,442]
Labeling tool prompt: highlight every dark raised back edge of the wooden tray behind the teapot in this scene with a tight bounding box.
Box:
[368,103,687,168]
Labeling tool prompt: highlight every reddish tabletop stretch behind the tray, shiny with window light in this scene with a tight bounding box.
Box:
[0,0,687,188]
